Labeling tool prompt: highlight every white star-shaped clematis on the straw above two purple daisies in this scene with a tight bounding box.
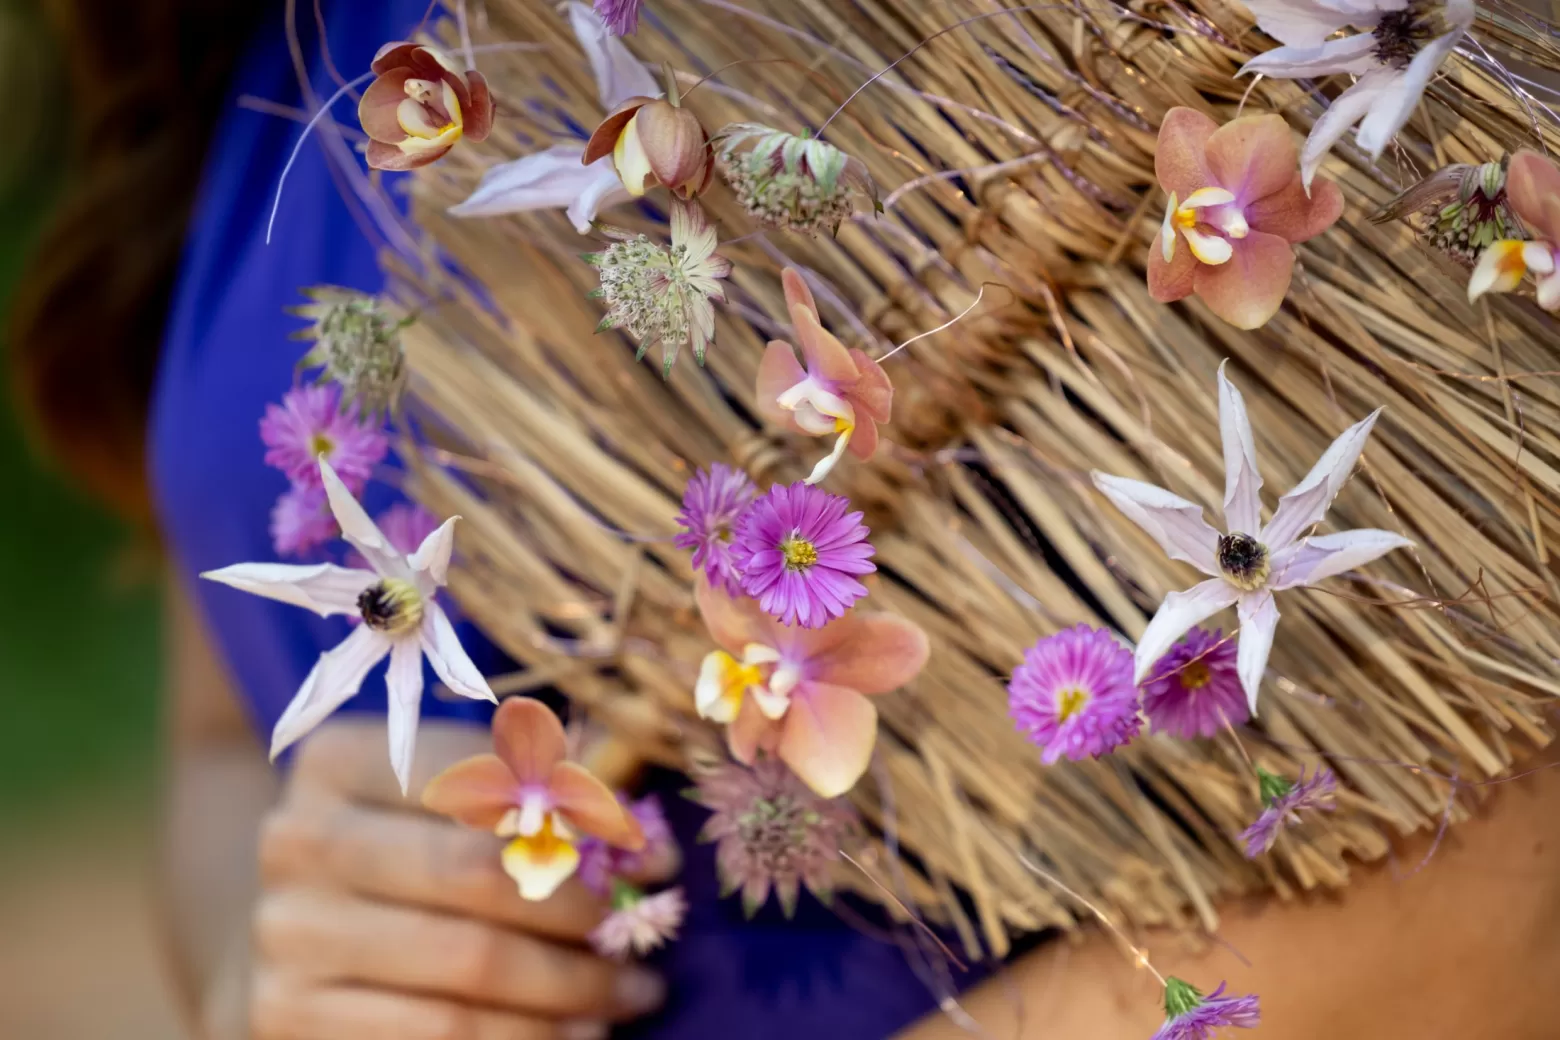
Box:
[1092,362,1413,714]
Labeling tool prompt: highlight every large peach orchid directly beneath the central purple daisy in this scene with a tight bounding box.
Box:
[694,580,930,798]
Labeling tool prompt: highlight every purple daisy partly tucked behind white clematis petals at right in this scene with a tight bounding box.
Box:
[1143,628,1251,741]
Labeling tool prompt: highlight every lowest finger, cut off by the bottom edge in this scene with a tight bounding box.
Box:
[250,971,607,1040]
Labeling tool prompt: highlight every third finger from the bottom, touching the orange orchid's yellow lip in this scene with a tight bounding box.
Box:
[261,803,605,943]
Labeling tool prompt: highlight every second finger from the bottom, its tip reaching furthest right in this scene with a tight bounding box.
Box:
[256,889,665,1021]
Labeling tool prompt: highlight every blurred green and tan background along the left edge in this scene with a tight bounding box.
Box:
[0,0,184,1040]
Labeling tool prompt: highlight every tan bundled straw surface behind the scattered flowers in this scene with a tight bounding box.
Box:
[392,0,1560,956]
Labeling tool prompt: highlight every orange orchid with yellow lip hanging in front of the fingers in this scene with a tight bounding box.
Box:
[423,697,644,900]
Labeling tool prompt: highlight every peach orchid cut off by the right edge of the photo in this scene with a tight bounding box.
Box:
[1468,148,1560,310]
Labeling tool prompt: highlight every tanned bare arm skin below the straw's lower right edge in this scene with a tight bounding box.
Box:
[902,755,1560,1040]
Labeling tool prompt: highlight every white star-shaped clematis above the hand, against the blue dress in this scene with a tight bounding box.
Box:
[201,458,496,794]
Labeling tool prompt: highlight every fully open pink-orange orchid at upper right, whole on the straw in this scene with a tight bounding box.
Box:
[1148,108,1343,329]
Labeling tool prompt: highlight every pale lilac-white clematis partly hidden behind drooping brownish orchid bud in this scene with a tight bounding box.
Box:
[449,0,661,234]
